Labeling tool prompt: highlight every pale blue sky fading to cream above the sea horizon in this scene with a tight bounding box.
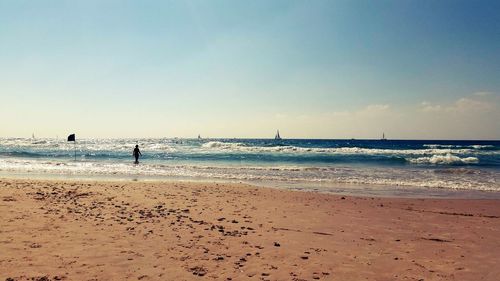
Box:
[0,0,500,139]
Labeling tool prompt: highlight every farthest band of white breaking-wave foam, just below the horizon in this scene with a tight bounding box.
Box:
[2,139,500,157]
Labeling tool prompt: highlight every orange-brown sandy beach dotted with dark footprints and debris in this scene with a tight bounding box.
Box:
[0,179,500,280]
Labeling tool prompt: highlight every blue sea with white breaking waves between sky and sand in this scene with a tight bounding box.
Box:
[0,138,500,196]
